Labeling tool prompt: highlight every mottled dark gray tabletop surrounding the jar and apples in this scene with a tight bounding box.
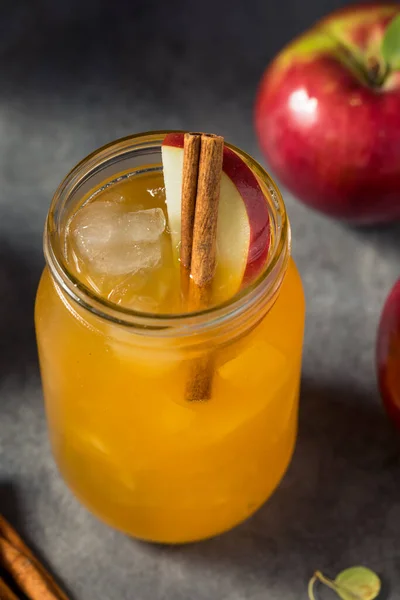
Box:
[0,0,400,600]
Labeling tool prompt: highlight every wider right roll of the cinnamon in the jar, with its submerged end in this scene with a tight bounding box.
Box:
[182,134,224,401]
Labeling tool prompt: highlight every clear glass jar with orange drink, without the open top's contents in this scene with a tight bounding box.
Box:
[35,132,305,543]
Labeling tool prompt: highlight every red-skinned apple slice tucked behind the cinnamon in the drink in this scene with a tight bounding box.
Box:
[162,133,270,302]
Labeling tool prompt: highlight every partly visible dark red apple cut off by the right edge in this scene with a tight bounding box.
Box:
[377,279,400,427]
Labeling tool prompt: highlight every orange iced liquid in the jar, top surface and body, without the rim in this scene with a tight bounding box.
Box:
[36,165,304,543]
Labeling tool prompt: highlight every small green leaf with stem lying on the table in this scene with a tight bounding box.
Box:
[308,566,381,600]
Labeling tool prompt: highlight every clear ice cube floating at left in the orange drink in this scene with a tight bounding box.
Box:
[70,202,165,276]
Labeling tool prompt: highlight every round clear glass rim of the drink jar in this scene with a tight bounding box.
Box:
[44,130,291,337]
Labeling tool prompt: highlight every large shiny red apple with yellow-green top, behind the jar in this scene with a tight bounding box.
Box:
[255,2,400,223]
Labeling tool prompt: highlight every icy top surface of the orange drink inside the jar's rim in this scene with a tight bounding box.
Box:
[66,166,253,314]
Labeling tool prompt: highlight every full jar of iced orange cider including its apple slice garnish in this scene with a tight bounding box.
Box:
[35,132,304,543]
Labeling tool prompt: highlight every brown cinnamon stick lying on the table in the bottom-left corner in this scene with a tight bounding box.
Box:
[0,515,68,600]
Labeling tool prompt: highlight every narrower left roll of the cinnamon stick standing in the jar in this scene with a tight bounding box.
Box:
[180,133,201,300]
